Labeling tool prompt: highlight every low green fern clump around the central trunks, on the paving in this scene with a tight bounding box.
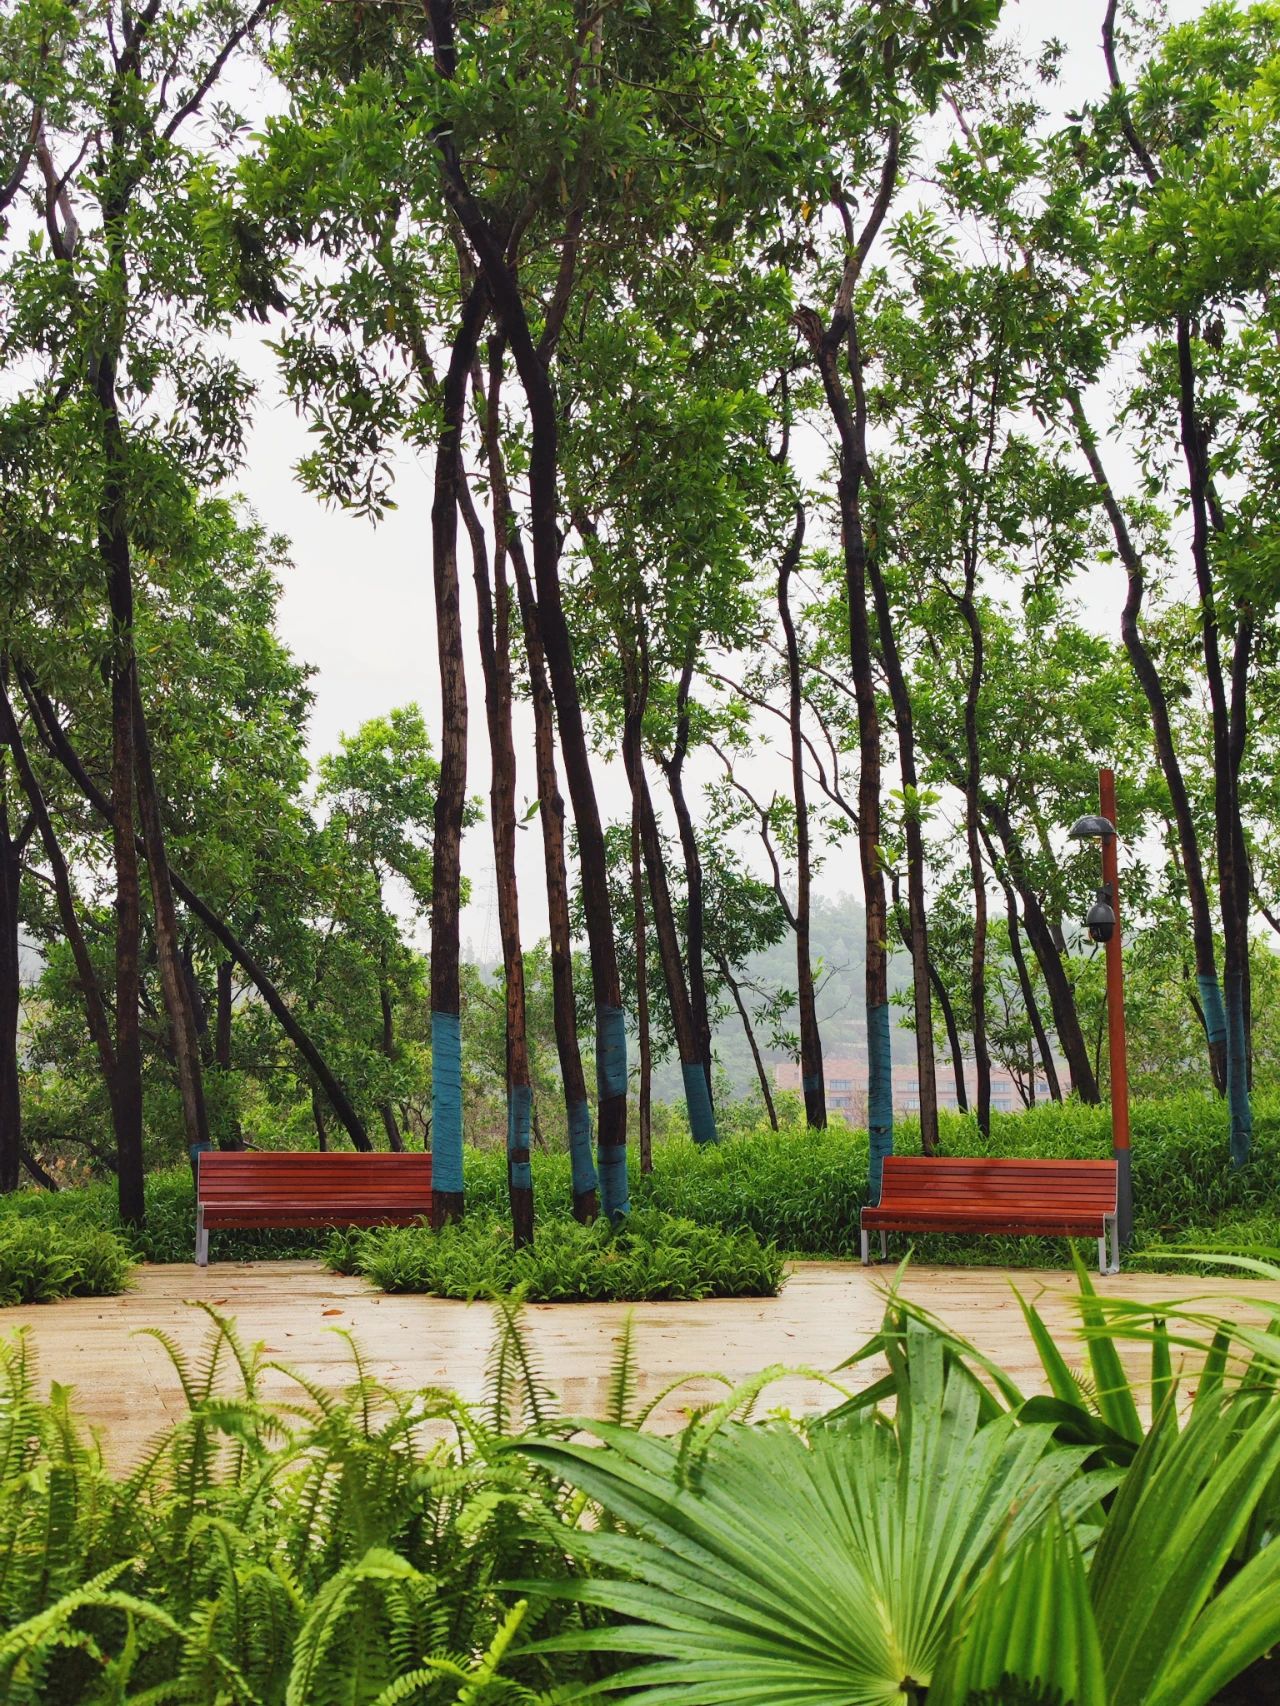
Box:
[326,1210,783,1303]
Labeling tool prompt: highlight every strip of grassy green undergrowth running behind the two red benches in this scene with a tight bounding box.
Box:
[0,1095,1280,1268]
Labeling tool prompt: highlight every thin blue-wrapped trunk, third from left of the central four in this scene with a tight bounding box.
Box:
[476,338,599,1223]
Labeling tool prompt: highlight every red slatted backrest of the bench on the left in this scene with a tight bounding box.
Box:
[196,1150,432,1215]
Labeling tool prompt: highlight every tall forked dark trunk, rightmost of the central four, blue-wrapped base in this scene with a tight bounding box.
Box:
[427,20,630,1221]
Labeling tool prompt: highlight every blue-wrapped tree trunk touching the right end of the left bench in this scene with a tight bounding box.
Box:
[432,283,488,1228]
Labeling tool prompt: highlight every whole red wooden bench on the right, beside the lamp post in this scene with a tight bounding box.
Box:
[862,1155,1120,1274]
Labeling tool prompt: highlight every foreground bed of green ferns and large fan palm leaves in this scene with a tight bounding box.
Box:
[0,1262,1280,1706]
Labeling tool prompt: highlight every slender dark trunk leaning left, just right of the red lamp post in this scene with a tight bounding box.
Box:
[1068,392,1227,1095]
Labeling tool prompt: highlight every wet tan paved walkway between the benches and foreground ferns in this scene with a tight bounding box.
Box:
[0,1262,1280,1464]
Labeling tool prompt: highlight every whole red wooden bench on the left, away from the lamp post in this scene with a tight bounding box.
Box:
[196,1150,432,1268]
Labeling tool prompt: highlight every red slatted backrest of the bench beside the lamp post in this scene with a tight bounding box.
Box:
[881,1155,1116,1215]
